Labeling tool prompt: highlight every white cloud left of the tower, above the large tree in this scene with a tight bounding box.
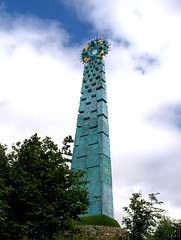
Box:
[0,12,81,145]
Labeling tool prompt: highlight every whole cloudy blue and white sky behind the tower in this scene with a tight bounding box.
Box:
[0,0,181,224]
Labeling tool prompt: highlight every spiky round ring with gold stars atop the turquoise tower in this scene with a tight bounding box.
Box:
[81,38,110,63]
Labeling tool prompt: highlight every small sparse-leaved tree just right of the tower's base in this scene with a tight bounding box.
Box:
[123,192,164,240]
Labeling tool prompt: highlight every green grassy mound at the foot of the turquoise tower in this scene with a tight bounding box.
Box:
[74,214,120,227]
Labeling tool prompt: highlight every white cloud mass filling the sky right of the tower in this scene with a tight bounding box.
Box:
[63,0,181,222]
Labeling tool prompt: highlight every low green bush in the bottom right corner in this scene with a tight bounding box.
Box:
[151,217,181,240]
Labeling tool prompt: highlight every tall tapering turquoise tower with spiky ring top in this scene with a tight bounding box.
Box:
[71,38,114,218]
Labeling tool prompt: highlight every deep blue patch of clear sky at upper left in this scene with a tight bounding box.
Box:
[4,0,92,44]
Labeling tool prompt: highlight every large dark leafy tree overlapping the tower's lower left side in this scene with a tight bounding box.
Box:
[0,134,90,240]
